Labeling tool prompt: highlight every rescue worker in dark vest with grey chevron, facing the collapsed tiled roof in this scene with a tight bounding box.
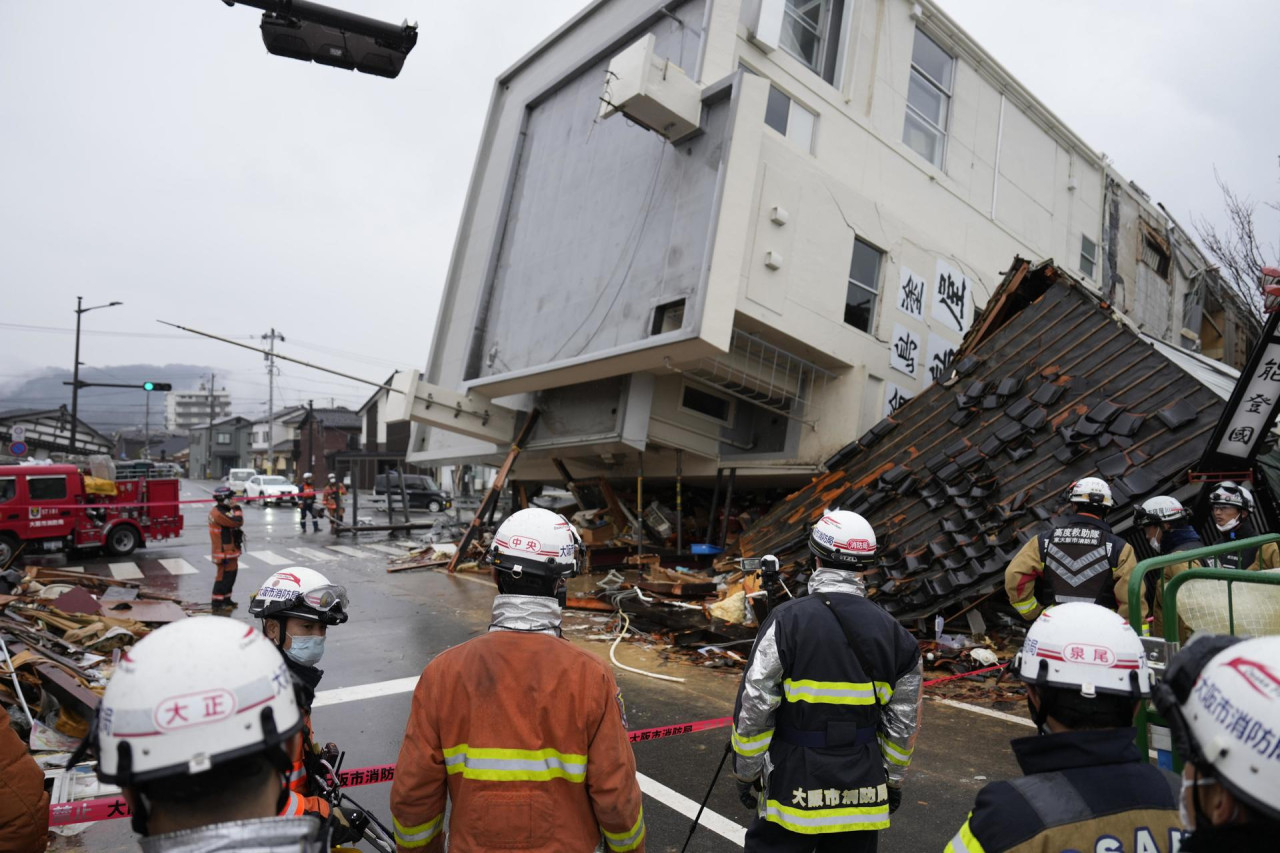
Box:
[1005,476,1146,621]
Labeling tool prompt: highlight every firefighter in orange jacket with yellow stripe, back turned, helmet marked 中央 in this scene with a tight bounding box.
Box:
[390,507,645,853]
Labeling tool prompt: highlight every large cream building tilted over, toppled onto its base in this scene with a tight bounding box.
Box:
[407,0,1256,482]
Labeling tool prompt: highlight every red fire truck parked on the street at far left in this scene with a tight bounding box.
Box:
[0,465,182,565]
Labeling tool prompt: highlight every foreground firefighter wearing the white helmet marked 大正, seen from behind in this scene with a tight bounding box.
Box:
[84,616,329,853]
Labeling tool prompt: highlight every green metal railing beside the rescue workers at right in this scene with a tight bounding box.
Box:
[1129,533,1280,770]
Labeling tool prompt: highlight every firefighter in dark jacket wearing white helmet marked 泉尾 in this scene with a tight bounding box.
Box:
[945,602,1185,853]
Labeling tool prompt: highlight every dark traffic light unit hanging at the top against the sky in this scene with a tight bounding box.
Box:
[223,0,417,77]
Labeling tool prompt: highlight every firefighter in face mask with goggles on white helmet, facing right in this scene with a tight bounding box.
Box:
[248,566,349,817]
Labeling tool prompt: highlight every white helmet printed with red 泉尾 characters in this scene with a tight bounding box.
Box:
[1014,602,1153,701]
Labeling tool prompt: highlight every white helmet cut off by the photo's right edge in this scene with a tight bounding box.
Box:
[1155,637,1280,820]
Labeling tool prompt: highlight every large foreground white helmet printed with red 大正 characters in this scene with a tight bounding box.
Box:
[90,616,302,786]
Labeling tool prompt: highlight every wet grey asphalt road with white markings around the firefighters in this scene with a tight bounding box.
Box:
[41,482,1030,853]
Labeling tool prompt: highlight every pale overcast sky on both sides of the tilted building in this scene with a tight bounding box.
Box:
[0,0,1280,414]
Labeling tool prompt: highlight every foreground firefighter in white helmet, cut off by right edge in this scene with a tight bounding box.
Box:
[1153,637,1280,853]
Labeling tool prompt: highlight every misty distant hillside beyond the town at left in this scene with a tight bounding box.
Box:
[0,364,221,433]
